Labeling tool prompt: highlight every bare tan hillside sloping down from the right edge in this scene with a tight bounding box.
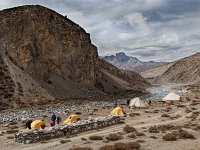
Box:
[141,53,200,83]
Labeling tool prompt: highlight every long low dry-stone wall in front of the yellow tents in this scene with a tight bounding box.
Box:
[15,116,120,144]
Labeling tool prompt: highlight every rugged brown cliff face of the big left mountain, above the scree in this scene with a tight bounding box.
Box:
[0,6,97,85]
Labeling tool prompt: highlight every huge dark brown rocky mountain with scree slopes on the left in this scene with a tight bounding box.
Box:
[0,5,150,107]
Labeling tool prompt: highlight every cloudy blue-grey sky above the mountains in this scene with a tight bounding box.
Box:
[0,0,200,61]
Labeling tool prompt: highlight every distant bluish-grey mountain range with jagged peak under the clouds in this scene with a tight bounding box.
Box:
[102,52,166,72]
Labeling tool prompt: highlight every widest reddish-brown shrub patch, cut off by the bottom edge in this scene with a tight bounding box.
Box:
[99,142,140,150]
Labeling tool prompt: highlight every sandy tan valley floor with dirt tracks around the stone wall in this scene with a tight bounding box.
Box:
[0,86,200,150]
